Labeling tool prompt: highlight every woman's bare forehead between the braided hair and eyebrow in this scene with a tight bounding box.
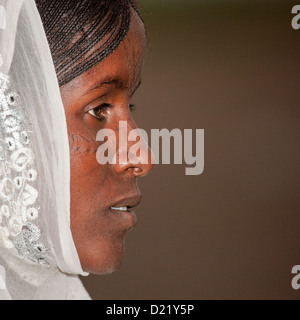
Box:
[63,10,146,93]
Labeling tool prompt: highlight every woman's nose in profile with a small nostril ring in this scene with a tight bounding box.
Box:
[114,121,153,177]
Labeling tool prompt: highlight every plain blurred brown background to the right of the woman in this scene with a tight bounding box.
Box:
[83,0,300,300]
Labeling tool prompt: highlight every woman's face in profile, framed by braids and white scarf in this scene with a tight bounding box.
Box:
[61,12,152,274]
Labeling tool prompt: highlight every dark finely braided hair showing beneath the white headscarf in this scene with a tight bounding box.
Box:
[35,0,137,86]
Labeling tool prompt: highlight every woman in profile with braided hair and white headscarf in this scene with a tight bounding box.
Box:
[0,0,152,299]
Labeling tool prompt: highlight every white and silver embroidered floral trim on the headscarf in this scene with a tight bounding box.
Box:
[0,73,50,264]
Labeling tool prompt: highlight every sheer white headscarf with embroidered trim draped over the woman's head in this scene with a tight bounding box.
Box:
[0,0,89,299]
